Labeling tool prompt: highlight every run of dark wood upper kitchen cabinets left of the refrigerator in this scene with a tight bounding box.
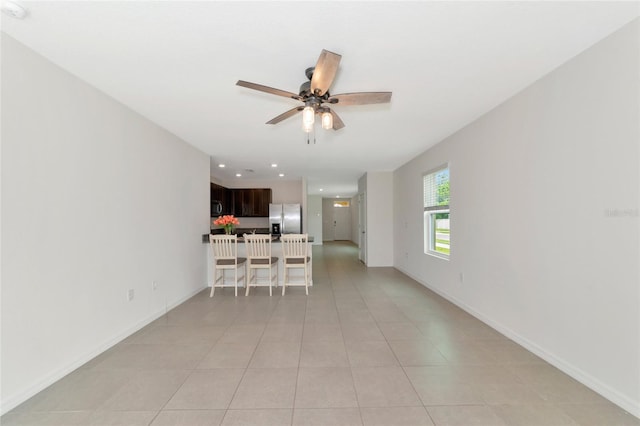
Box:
[211,183,272,217]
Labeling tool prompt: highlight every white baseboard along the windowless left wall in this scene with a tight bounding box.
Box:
[0,287,206,416]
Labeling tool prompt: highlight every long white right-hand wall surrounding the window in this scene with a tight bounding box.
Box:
[396,20,640,416]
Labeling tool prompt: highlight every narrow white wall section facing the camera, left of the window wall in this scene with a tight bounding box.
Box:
[358,172,394,266]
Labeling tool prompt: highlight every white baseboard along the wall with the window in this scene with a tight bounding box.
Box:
[395,266,640,418]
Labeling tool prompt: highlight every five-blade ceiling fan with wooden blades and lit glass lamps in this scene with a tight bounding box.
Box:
[236,49,391,133]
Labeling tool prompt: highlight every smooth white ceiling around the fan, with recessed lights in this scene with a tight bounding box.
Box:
[2,1,640,196]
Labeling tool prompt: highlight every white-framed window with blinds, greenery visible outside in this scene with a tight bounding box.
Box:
[423,165,451,258]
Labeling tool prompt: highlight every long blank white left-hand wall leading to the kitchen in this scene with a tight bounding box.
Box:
[1,34,209,412]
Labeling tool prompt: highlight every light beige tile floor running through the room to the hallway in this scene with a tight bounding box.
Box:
[0,243,640,426]
